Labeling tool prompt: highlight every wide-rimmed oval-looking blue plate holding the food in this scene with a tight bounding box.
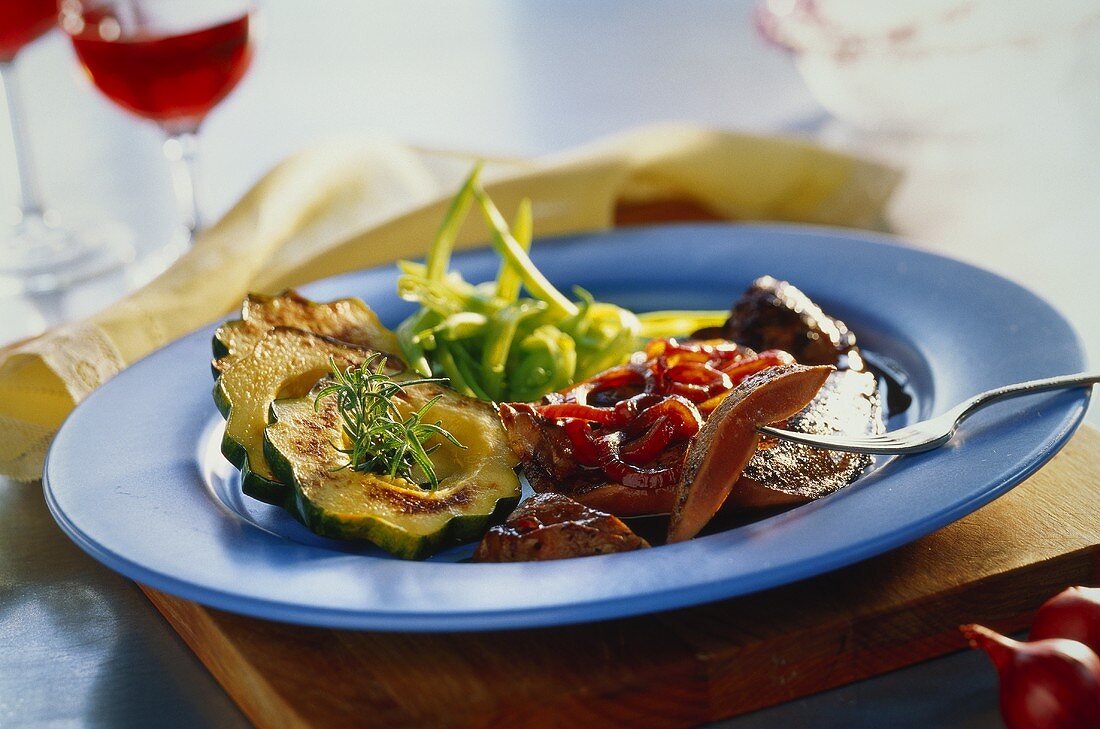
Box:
[44,224,1089,631]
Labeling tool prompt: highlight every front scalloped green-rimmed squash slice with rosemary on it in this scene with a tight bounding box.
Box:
[266,382,519,560]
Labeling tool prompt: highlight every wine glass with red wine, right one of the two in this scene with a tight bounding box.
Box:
[61,0,255,252]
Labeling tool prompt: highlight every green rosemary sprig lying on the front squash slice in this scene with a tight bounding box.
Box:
[314,354,465,490]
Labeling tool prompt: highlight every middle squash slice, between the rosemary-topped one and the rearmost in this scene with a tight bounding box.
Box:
[213,327,372,506]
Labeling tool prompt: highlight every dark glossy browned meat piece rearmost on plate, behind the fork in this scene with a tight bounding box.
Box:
[695,276,862,369]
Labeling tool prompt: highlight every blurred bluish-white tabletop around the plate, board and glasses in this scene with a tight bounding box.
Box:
[0,0,1100,727]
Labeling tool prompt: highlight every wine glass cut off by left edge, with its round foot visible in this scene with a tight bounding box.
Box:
[0,0,133,294]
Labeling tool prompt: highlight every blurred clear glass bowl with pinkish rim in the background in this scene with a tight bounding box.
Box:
[756,0,1100,136]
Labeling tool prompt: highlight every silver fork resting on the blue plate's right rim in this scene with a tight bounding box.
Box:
[758,373,1100,455]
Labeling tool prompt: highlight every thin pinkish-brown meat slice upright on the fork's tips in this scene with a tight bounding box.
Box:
[668,365,833,542]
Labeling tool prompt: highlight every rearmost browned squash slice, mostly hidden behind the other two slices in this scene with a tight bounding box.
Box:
[210,290,400,377]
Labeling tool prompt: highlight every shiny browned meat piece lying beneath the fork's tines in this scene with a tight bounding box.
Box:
[729,369,884,507]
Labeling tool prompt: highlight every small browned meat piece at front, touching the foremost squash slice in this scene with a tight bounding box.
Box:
[474,494,649,562]
